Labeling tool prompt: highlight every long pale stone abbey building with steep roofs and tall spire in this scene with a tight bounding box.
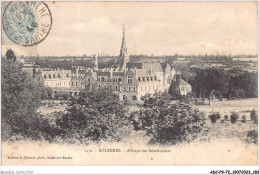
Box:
[34,29,191,100]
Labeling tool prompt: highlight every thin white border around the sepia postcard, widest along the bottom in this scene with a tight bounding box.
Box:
[0,0,260,175]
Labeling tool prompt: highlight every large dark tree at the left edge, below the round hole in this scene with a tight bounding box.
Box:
[1,59,47,139]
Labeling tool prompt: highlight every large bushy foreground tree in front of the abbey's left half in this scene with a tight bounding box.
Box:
[56,89,128,141]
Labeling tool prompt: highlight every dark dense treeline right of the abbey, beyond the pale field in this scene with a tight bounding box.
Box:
[188,68,258,99]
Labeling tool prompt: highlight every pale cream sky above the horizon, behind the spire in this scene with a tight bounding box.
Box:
[2,1,258,56]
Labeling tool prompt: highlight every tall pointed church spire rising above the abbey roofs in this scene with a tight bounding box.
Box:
[119,27,129,70]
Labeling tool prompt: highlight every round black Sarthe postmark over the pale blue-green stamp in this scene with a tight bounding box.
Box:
[2,1,52,46]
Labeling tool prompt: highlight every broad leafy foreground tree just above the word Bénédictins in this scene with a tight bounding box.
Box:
[136,93,205,144]
